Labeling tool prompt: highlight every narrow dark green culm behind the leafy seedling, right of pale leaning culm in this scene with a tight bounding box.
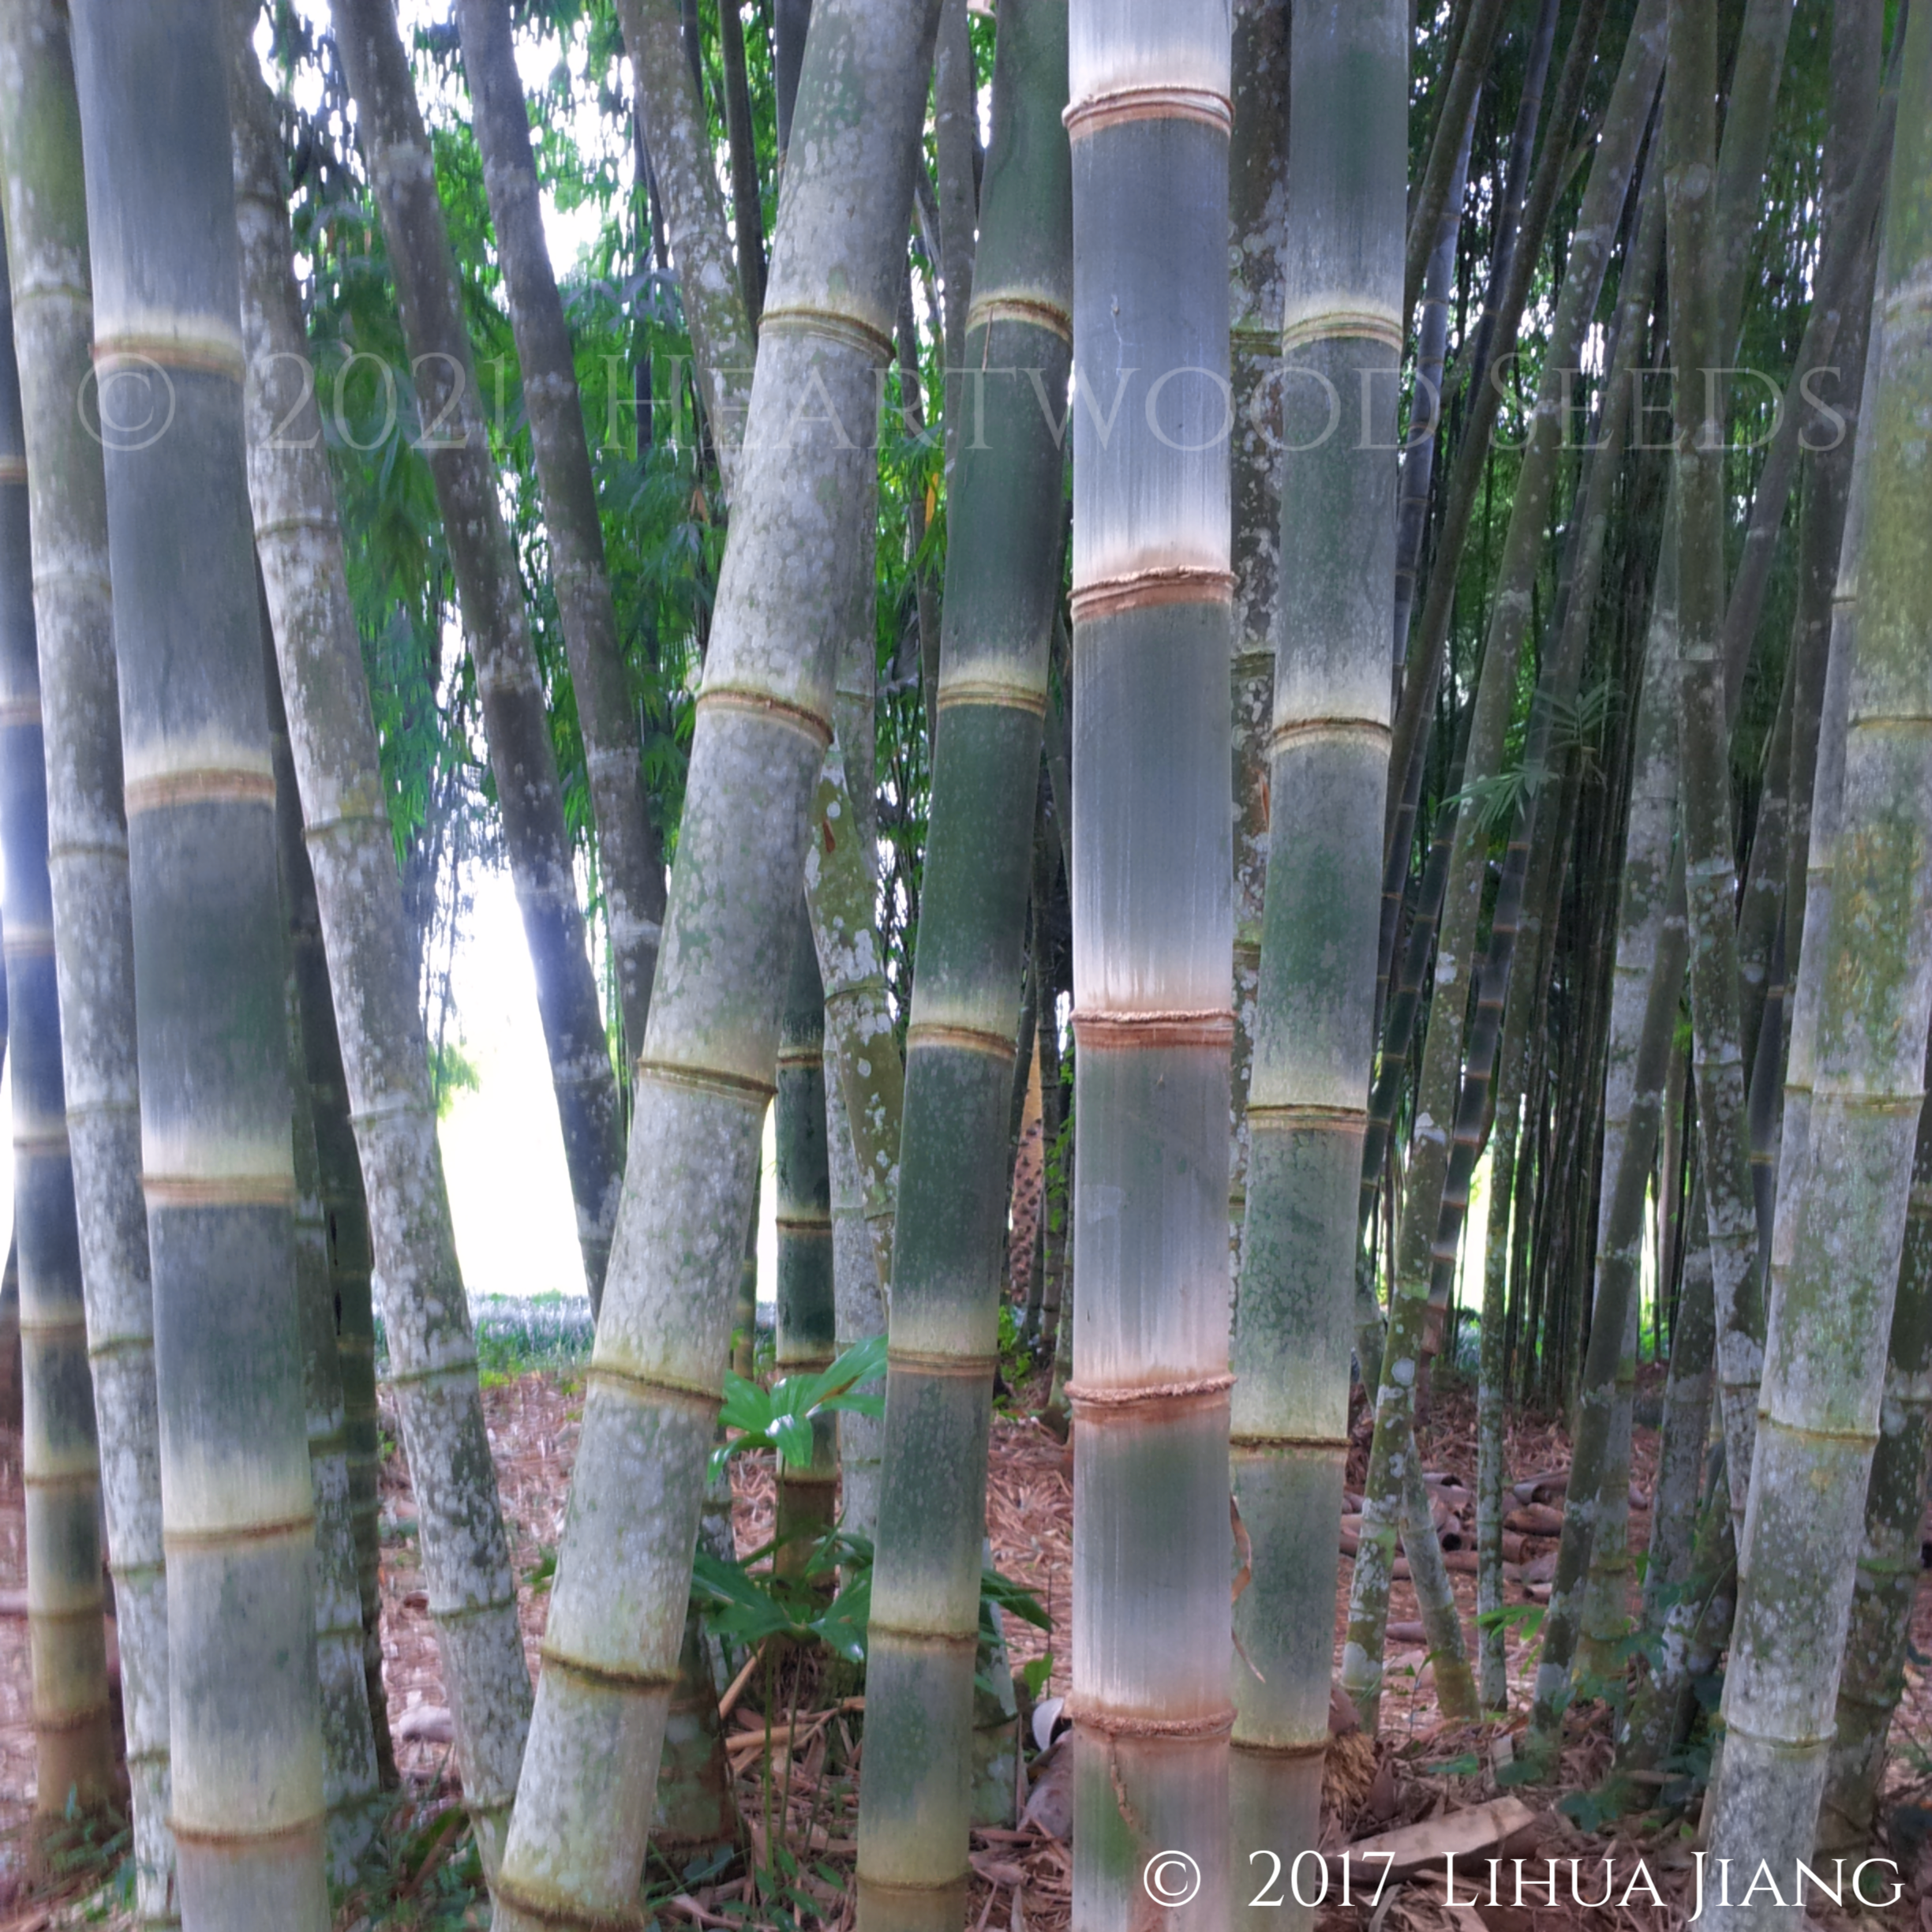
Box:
[775,900,838,1567]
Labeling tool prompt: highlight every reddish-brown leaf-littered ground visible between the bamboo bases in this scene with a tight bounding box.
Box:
[0,1370,1932,1932]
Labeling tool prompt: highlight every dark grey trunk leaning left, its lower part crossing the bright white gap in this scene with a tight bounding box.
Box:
[332,0,626,1312]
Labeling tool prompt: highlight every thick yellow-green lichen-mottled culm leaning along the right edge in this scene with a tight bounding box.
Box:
[1708,9,1932,1885]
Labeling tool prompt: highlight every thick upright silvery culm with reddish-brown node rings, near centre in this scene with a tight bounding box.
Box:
[1069,0,1228,1932]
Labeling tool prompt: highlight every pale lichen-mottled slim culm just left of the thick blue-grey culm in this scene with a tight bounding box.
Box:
[0,0,178,1926]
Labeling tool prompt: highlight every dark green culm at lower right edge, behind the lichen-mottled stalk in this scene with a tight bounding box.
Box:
[1818,1035,1932,1853]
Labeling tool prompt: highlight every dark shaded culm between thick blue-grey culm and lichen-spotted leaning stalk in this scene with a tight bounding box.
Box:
[260,633,376,1885]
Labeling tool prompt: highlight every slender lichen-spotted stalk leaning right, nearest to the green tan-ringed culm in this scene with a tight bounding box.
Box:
[1342,0,1664,1721]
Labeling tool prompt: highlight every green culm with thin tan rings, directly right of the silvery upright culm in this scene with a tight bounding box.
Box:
[1230,0,1409,1924]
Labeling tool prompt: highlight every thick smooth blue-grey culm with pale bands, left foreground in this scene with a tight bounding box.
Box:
[67,0,328,1932]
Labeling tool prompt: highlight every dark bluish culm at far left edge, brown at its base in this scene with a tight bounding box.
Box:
[0,215,114,1818]
